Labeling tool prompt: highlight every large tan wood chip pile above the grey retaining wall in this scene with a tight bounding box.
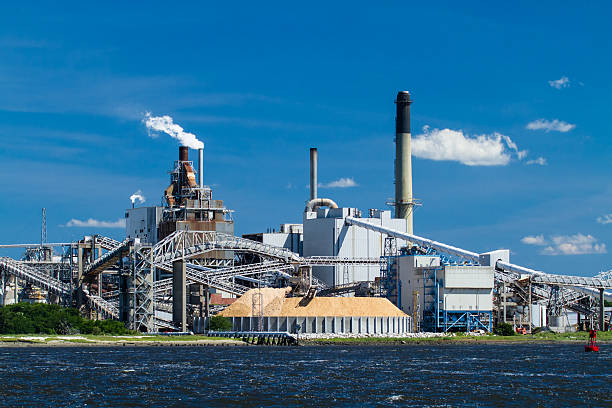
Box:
[220,288,406,317]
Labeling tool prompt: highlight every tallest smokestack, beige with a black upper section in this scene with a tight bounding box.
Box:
[395,91,414,234]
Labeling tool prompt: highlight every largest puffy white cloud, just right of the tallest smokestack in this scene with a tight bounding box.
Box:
[412,126,527,166]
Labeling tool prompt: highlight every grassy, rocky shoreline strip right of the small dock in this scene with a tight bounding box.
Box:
[300,332,612,345]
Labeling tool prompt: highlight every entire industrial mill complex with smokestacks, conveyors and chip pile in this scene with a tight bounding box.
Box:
[0,91,612,336]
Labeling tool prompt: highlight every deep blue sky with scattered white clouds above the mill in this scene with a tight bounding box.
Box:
[0,2,612,275]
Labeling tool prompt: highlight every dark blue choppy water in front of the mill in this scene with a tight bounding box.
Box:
[0,345,612,408]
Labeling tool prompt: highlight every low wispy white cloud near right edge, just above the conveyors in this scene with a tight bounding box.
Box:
[521,233,608,255]
